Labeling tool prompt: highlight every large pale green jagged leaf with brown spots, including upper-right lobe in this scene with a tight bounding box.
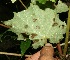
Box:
[4,1,68,49]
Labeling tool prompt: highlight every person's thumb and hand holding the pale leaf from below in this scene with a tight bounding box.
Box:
[25,43,58,60]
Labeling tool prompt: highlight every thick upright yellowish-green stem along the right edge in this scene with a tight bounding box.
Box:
[63,7,70,56]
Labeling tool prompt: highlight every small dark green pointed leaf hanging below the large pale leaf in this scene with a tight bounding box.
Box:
[20,39,31,56]
